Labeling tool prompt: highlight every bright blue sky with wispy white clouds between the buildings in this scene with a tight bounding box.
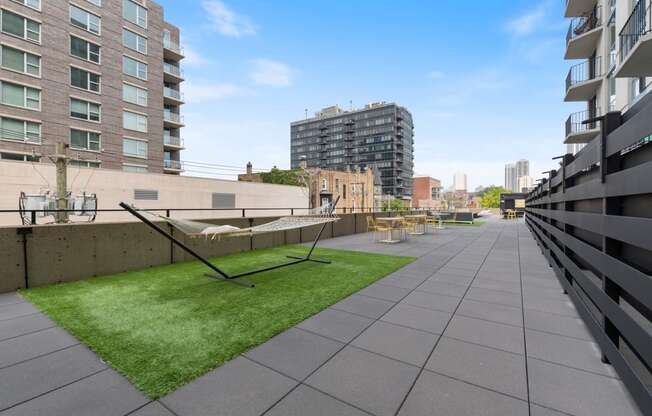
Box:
[158,0,576,189]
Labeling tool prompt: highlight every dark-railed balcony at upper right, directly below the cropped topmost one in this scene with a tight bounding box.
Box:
[564,6,603,59]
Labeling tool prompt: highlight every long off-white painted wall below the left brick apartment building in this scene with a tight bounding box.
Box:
[0,161,308,225]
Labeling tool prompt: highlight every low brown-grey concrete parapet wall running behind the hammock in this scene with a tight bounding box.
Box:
[0,213,376,293]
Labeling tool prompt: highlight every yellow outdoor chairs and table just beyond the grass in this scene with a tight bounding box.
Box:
[367,213,444,244]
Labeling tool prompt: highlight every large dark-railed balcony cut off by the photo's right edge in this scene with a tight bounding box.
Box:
[616,0,652,78]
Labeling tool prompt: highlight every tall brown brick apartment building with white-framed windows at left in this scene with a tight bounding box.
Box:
[0,0,183,174]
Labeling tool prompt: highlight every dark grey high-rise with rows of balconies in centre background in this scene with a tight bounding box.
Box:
[290,102,414,199]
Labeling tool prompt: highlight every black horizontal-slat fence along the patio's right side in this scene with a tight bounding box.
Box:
[526,91,652,414]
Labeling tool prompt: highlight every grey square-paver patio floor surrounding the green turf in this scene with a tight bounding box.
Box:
[0,219,641,416]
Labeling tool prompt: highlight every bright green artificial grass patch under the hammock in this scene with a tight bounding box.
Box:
[21,246,414,398]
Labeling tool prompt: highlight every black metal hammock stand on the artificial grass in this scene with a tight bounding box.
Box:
[120,196,340,287]
